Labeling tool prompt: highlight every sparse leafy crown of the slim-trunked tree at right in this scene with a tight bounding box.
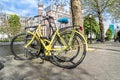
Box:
[81,0,116,17]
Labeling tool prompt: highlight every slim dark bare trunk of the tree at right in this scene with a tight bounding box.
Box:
[98,12,105,43]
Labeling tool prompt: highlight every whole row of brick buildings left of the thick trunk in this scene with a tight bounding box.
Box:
[0,0,72,36]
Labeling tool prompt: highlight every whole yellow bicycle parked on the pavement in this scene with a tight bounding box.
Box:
[10,16,88,69]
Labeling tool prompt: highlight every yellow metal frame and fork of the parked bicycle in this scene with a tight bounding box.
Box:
[24,24,67,56]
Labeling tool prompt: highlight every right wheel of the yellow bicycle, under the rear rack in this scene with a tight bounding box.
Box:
[52,31,86,69]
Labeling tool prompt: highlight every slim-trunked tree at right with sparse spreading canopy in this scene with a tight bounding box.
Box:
[82,0,116,43]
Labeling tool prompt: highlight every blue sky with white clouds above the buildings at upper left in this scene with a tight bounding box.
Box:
[0,0,48,16]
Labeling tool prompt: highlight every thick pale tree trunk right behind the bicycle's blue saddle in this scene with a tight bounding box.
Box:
[71,0,84,34]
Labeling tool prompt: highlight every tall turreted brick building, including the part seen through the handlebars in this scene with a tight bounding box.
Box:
[38,0,72,36]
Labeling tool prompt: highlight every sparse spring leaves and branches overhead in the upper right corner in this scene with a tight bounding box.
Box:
[81,0,120,20]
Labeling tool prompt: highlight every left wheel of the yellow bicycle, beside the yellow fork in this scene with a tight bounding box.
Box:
[10,33,40,60]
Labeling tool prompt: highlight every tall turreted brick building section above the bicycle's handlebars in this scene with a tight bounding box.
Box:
[38,0,72,27]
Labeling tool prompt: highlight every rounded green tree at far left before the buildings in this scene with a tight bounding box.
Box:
[8,15,21,35]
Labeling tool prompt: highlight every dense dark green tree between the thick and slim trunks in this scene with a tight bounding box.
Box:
[84,15,100,36]
